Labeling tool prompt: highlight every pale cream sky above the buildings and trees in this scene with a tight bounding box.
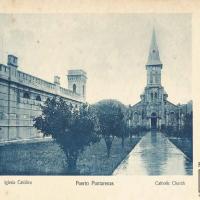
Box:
[0,13,192,105]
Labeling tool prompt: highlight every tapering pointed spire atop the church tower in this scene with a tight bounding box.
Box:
[146,28,162,65]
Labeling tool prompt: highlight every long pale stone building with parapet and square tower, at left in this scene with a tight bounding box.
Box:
[0,55,87,142]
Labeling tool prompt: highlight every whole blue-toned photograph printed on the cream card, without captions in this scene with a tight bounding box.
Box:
[0,13,193,176]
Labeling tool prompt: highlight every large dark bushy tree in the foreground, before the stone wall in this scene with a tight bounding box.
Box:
[34,97,98,173]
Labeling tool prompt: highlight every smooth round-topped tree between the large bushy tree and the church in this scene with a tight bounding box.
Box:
[94,100,126,157]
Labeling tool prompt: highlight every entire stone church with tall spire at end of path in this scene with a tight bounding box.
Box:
[130,30,189,129]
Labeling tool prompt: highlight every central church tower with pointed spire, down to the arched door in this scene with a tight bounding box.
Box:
[143,29,167,129]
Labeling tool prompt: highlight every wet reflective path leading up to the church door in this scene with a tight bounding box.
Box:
[113,132,192,175]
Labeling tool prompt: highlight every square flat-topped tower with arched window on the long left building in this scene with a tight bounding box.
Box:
[67,69,87,99]
